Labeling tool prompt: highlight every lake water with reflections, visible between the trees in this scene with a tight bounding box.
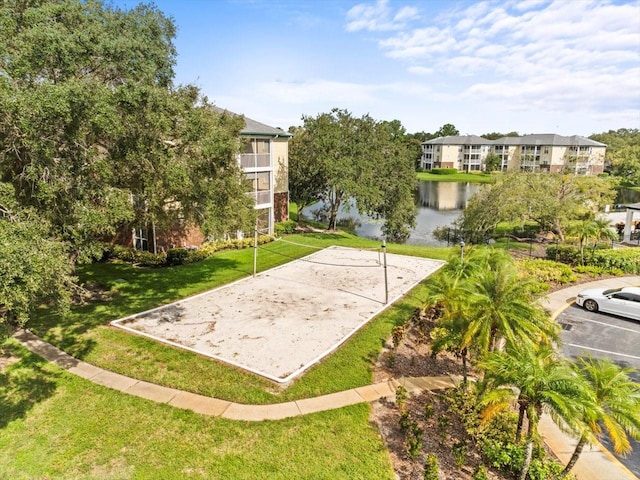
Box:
[302,181,640,246]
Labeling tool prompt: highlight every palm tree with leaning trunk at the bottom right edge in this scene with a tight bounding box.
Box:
[560,357,640,478]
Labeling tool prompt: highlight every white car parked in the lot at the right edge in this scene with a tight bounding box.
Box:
[576,287,640,320]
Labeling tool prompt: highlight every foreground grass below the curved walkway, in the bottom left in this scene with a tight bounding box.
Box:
[0,342,394,480]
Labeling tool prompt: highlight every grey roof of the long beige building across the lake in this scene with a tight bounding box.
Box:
[422,133,606,147]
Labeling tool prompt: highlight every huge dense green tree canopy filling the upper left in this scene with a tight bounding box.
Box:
[0,0,254,326]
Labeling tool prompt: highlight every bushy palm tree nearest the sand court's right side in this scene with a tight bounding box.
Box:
[463,250,558,352]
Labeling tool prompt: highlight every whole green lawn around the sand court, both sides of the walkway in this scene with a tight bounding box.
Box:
[0,233,451,479]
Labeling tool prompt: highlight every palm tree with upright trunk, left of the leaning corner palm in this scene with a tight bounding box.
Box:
[480,345,593,480]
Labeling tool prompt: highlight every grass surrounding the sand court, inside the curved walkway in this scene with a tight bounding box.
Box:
[29,232,450,404]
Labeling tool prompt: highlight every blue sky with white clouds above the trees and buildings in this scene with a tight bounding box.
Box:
[113,0,640,136]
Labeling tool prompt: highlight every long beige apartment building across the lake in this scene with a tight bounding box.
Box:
[421,134,607,175]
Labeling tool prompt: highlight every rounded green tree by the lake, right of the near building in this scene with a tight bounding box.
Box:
[289,108,417,241]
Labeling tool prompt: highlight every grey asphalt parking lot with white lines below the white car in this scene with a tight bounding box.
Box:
[557,304,640,478]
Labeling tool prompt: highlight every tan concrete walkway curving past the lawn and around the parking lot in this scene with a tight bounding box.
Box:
[14,276,640,480]
